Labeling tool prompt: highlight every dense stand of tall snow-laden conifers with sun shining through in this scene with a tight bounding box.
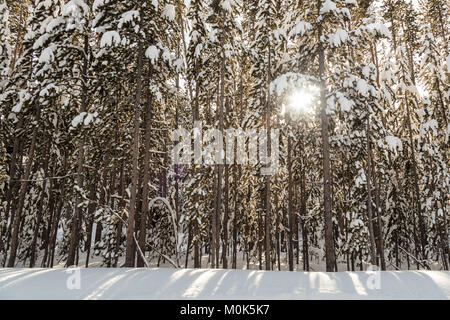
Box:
[0,0,450,271]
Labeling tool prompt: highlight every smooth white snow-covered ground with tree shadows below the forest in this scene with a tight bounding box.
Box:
[0,268,450,300]
